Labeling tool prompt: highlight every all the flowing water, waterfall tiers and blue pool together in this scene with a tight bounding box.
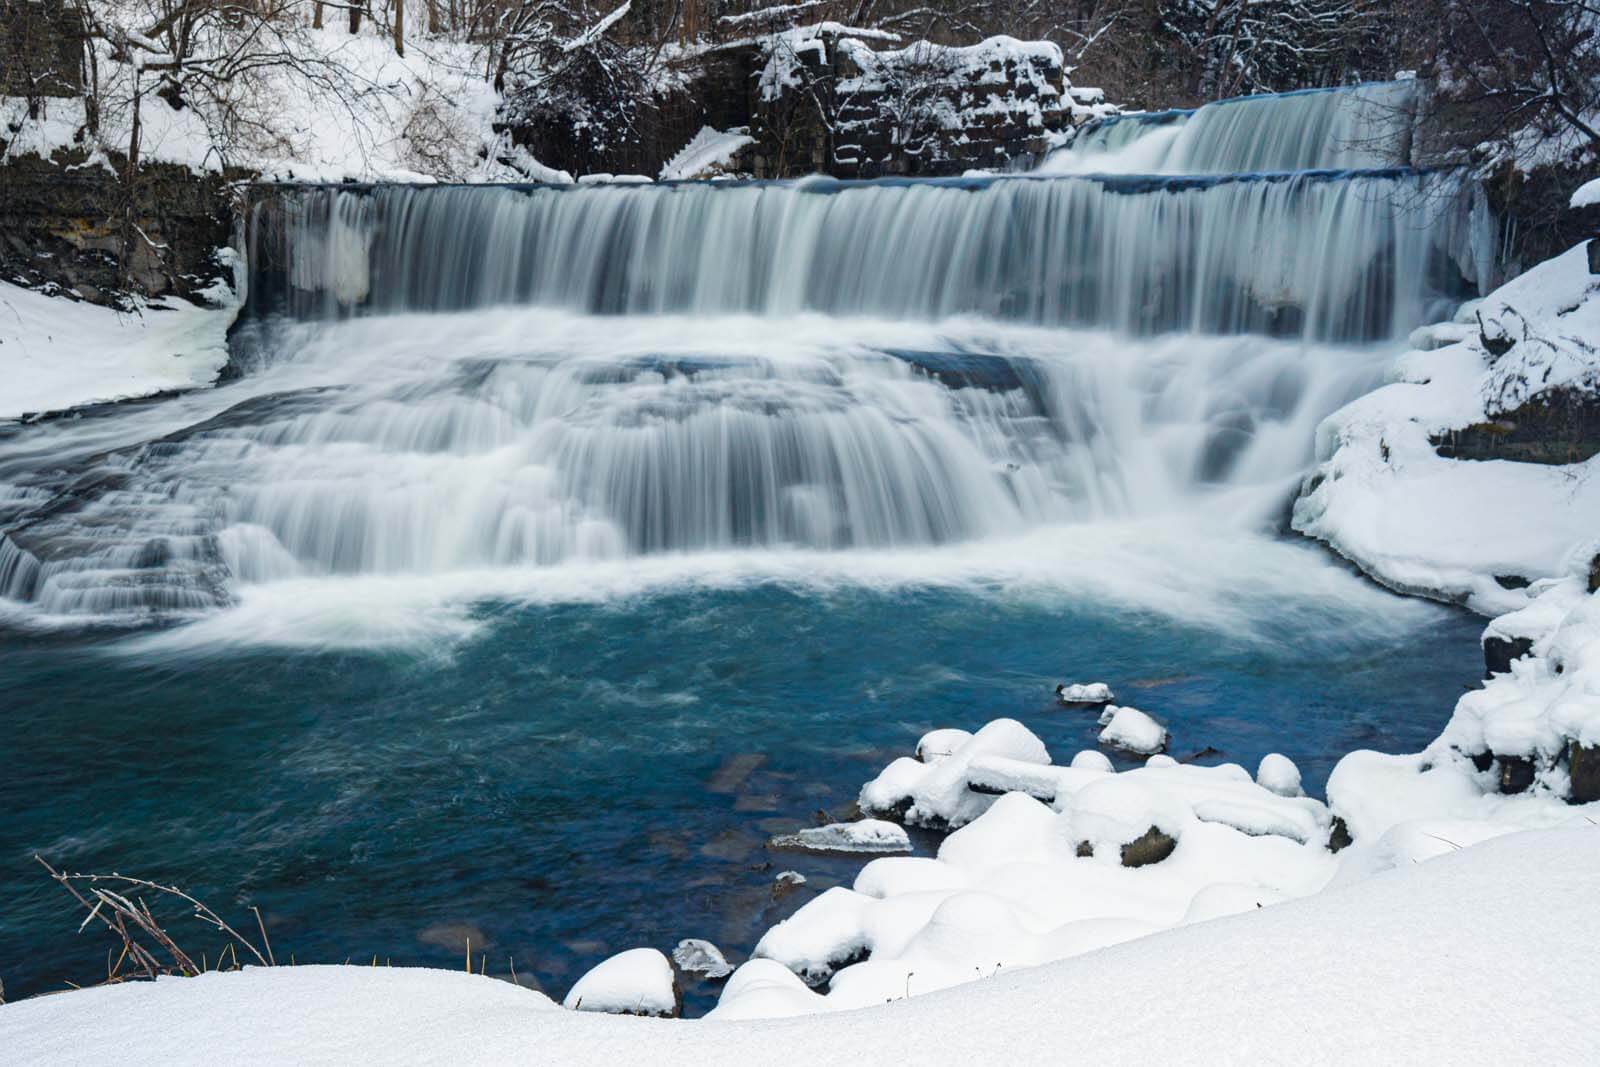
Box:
[0,86,1496,1003]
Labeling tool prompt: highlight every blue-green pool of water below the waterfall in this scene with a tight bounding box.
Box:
[0,579,1480,1013]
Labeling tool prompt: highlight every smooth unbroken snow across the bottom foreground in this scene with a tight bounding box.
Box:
[0,827,1600,1067]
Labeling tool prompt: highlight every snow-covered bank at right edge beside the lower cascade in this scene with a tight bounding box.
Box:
[1293,245,1600,614]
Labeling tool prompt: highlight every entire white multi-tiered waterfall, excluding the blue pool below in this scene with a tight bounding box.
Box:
[0,86,1496,622]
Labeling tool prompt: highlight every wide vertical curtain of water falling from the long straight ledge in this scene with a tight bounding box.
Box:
[248,171,1493,341]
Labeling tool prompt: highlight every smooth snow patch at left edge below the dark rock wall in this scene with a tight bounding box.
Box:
[0,282,237,421]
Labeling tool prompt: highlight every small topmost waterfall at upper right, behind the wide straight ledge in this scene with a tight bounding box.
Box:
[1040,82,1416,174]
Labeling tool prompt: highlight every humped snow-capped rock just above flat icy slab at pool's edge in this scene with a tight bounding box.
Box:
[859,718,1050,829]
